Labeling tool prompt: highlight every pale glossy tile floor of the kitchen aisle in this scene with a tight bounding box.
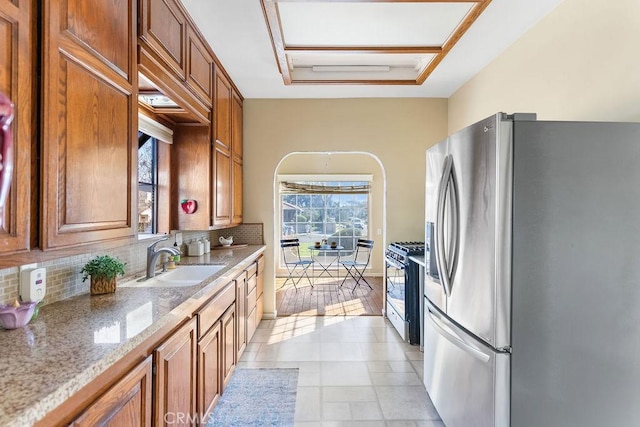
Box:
[238,316,444,427]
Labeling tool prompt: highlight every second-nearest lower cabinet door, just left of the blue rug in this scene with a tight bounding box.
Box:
[153,319,196,426]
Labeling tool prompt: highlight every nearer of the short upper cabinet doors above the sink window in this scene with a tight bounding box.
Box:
[140,0,182,79]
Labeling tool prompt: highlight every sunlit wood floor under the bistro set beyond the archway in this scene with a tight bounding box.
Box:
[276,277,383,316]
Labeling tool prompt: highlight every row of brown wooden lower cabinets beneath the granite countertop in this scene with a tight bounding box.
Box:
[39,261,262,427]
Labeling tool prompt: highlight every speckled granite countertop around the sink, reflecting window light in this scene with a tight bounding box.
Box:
[0,245,265,426]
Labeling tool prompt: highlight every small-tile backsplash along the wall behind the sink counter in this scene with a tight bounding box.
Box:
[0,224,264,304]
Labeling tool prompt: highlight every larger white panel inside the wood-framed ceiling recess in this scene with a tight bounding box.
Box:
[278,2,475,46]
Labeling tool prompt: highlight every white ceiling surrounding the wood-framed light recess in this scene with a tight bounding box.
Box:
[182,0,562,98]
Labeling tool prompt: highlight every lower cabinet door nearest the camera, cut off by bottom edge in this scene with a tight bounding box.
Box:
[71,356,152,427]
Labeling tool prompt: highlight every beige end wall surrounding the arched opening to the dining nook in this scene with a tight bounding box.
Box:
[243,99,447,315]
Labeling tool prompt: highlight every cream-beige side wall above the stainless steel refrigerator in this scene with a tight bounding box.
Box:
[448,0,640,133]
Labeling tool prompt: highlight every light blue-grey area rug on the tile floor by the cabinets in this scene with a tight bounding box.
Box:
[207,368,298,427]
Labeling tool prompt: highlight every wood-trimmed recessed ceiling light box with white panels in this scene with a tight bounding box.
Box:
[260,0,491,85]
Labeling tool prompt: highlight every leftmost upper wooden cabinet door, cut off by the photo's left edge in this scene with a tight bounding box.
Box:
[0,0,37,254]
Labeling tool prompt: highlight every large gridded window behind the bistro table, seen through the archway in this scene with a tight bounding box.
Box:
[279,175,371,264]
